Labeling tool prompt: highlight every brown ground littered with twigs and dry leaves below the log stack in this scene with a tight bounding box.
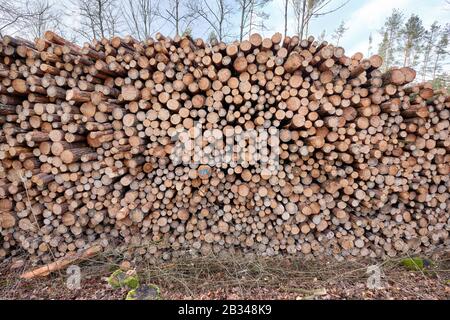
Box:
[0,252,450,300]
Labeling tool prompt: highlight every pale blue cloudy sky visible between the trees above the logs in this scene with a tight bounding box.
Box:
[5,0,450,55]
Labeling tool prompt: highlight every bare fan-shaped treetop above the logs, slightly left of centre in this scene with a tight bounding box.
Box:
[158,0,198,36]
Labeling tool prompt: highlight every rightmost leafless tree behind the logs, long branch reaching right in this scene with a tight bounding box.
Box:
[291,0,350,39]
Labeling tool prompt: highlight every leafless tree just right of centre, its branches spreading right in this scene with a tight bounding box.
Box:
[237,0,271,41]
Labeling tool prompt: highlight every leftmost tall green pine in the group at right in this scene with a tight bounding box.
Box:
[378,9,403,70]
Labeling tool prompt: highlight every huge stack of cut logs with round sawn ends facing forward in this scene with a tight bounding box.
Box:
[0,32,450,263]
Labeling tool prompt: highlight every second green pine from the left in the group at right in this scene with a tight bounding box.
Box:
[401,14,425,67]
